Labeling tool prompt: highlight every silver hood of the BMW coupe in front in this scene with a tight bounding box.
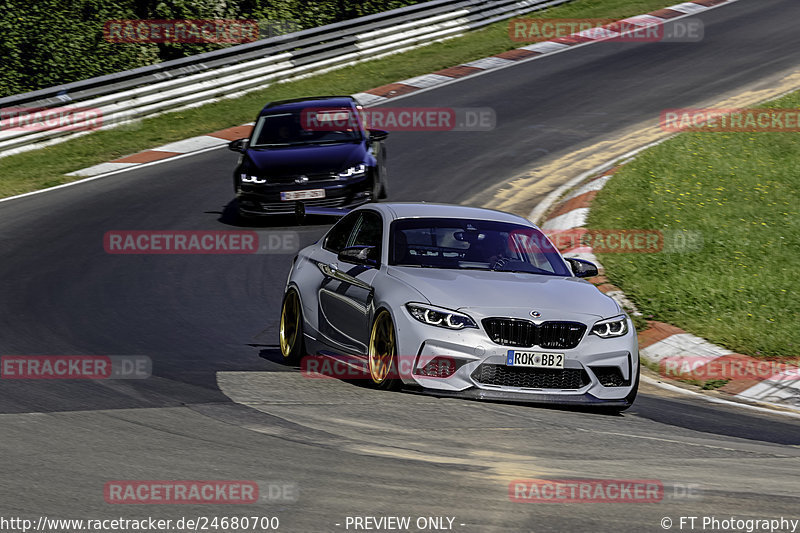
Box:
[388,267,622,318]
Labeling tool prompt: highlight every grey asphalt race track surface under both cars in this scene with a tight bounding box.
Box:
[0,0,800,532]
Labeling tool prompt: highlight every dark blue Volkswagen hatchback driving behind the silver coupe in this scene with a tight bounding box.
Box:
[229,96,388,217]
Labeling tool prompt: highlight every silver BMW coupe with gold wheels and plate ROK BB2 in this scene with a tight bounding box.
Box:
[280,203,639,411]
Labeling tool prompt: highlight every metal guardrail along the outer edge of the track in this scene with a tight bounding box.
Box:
[0,0,569,157]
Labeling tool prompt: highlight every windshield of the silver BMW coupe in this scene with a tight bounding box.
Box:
[389,218,572,276]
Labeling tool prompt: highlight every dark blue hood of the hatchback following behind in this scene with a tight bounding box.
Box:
[243,142,365,175]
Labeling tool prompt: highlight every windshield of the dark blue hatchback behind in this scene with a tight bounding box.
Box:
[250,109,362,148]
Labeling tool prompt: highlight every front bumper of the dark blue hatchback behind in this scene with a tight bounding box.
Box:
[236,176,372,216]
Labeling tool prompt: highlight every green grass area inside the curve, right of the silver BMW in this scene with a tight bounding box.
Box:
[588,93,800,357]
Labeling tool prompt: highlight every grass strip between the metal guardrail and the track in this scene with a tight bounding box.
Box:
[0,0,668,197]
